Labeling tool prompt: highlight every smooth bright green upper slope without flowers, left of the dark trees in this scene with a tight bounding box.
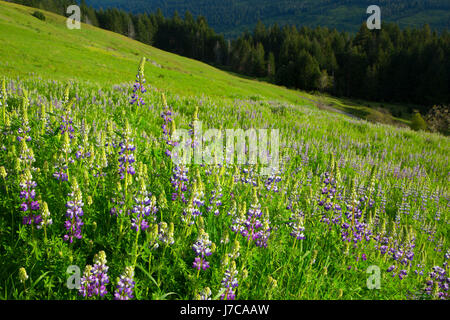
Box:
[0,1,310,104]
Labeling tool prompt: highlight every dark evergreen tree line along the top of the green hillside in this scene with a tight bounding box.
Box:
[10,0,450,112]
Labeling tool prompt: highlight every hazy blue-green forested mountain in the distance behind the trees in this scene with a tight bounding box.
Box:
[86,0,450,37]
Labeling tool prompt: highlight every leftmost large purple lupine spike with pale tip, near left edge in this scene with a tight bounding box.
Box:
[19,169,42,225]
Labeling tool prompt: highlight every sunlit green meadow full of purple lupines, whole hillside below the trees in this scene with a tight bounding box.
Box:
[0,3,450,300]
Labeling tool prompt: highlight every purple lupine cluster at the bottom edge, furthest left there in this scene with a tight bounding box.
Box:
[79,251,109,298]
